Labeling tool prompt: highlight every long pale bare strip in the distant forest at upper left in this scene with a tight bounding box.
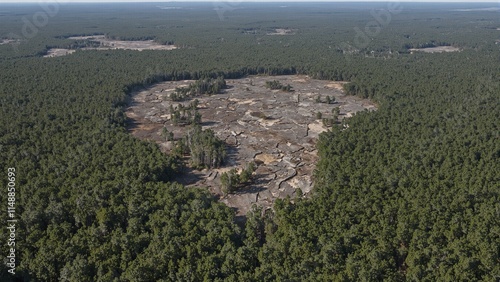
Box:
[44,35,177,57]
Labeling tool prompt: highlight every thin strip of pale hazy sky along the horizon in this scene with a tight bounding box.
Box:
[0,0,500,2]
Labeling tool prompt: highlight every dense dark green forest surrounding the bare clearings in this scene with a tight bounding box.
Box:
[0,2,500,281]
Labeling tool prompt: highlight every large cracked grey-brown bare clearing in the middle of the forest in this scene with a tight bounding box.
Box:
[126,76,375,215]
